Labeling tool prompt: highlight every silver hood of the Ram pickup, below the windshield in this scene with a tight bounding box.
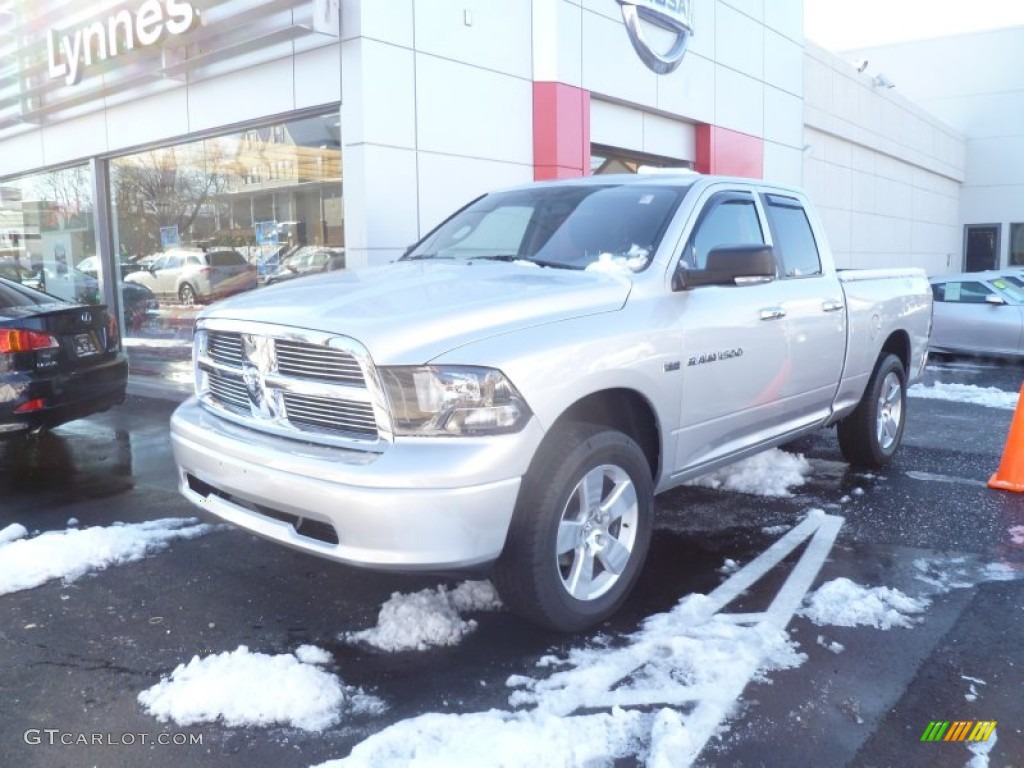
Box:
[201,260,632,366]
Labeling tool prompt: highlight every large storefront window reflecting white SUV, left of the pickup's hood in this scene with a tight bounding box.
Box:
[110,114,345,388]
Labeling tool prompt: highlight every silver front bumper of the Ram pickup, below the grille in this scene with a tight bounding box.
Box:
[171,398,543,570]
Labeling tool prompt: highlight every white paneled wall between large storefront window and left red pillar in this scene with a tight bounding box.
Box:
[341,0,534,266]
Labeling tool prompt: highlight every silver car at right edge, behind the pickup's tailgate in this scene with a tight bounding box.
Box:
[929,270,1024,355]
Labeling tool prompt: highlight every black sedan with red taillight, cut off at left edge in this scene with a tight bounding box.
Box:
[0,278,128,438]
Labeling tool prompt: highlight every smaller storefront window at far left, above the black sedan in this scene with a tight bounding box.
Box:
[0,165,101,304]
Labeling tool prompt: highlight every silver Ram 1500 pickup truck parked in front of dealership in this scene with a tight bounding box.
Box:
[171,174,932,631]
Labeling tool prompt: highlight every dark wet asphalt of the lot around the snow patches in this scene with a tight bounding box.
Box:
[0,360,1024,768]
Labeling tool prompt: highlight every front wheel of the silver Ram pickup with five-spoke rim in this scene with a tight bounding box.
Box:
[494,424,654,632]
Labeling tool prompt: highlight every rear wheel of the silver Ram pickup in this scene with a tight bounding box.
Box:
[837,354,906,469]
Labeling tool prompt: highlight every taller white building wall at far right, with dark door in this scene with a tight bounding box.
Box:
[847,27,1024,264]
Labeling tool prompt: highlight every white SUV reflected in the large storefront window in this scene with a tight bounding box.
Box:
[124,248,256,306]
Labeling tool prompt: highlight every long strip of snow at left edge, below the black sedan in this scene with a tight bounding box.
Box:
[0,517,213,595]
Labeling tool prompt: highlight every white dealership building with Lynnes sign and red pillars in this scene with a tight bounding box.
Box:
[0,0,1024,388]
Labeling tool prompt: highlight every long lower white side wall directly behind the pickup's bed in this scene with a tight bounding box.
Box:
[803,43,966,274]
